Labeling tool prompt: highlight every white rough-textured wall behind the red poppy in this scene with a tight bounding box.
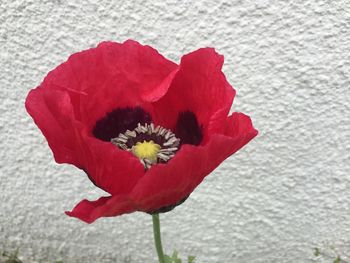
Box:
[0,0,350,263]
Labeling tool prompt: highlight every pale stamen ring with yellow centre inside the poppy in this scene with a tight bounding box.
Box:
[111,123,180,170]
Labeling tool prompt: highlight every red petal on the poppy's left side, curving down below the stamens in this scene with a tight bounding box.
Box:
[26,84,144,194]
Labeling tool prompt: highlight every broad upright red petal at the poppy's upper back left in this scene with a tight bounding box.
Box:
[37,40,178,134]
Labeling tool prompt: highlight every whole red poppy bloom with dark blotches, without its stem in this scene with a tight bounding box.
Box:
[26,40,257,223]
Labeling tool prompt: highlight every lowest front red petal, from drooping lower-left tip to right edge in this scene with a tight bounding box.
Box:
[66,113,257,223]
